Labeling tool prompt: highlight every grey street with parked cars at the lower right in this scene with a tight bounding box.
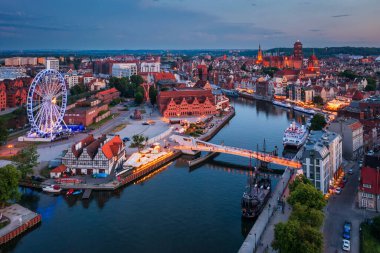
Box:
[323,162,377,253]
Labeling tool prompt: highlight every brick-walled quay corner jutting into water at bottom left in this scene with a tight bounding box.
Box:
[0,204,41,245]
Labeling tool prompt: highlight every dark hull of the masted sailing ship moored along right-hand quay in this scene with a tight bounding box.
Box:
[241,174,271,218]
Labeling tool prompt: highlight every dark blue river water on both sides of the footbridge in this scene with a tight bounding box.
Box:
[0,99,305,253]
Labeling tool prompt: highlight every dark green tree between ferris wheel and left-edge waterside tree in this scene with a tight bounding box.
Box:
[12,145,40,179]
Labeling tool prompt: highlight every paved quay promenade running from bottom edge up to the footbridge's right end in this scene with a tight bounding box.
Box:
[239,148,302,253]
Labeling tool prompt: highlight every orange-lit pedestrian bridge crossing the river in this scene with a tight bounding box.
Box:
[170,135,302,169]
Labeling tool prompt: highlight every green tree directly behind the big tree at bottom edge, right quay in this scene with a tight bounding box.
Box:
[290,203,324,229]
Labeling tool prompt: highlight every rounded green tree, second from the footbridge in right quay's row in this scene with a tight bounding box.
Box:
[288,183,326,210]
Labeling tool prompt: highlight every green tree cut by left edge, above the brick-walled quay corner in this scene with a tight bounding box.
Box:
[0,164,21,207]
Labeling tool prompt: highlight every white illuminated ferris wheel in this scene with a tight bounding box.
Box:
[27,69,67,138]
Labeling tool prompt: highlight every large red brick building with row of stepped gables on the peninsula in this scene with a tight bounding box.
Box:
[157,88,217,117]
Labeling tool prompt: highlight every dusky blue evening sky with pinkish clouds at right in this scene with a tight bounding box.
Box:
[0,0,380,50]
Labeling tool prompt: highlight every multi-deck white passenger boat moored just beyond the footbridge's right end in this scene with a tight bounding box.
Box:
[282,121,309,148]
